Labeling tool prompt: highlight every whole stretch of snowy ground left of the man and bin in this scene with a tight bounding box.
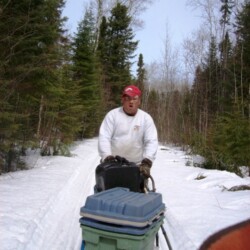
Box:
[0,141,99,250]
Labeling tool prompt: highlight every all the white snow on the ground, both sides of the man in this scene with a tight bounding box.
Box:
[0,138,250,250]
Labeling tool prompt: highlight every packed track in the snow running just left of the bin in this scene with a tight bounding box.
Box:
[23,140,99,250]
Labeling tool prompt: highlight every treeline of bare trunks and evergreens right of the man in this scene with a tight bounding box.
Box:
[147,0,250,174]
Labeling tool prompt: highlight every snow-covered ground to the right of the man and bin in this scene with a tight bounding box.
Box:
[152,147,250,250]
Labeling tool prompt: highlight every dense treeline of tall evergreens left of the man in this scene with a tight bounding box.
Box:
[0,0,145,172]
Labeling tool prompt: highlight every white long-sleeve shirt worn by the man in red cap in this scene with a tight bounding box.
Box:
[98,107,158,163]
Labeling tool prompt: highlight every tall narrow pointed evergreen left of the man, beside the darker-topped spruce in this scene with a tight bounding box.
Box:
[73,5,101,137]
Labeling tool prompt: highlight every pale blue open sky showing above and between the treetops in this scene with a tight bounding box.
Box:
[63,0,201,64]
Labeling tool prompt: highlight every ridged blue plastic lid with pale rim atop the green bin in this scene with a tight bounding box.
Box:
[80,187,165,227]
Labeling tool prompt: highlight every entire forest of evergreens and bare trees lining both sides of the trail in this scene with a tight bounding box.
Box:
[0,0,250,175]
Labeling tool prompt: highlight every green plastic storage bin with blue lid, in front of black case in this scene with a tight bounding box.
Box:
[80,187,165,250]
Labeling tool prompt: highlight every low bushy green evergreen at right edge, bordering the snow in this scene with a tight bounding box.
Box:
[205,112,250,174]
